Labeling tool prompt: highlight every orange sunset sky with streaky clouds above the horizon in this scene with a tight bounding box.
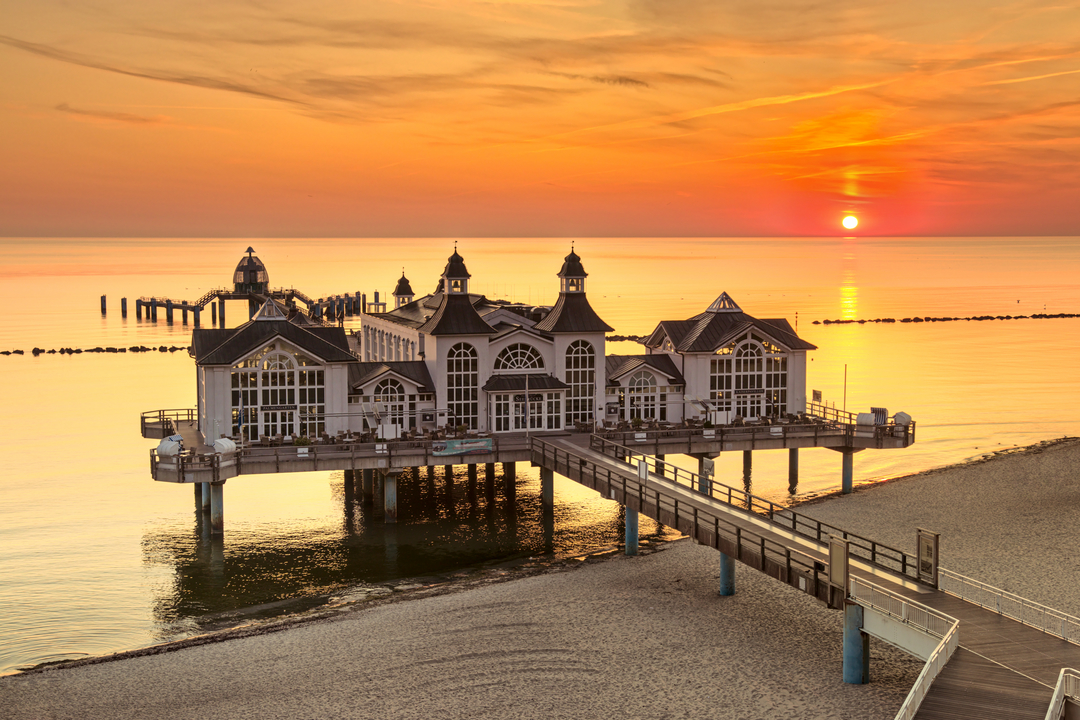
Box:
[0,0,1080,237]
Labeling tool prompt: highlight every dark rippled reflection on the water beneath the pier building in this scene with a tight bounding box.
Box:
[143,466,673,637]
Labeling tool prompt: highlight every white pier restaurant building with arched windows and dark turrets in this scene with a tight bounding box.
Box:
[191,249,814,445]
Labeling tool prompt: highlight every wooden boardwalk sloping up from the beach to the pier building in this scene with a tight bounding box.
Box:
[532,438,1080,720]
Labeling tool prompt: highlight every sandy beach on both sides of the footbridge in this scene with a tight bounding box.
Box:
[0,440,1080,720]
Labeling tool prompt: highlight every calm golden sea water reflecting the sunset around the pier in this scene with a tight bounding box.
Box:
[0,237,1080,673]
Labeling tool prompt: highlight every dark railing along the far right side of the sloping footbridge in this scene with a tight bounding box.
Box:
[590,435,919,581]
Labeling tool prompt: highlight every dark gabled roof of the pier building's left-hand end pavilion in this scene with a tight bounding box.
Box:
[191,320,356,366]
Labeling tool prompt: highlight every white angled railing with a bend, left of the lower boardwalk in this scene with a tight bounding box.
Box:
[849,578,960,720]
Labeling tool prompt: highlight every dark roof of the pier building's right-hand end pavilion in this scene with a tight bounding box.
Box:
[645,311,818,353]
